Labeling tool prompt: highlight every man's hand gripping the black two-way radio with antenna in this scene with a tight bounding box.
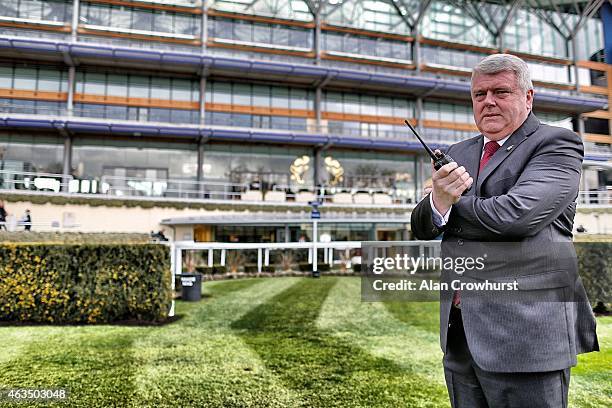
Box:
[431,162,474,216]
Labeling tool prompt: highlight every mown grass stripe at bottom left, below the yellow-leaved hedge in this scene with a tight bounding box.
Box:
[0,326,146,407]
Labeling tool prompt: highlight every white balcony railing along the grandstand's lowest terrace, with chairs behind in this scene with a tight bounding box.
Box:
[0,170,612,207]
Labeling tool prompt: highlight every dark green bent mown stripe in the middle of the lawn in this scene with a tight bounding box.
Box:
[232,278,447,407]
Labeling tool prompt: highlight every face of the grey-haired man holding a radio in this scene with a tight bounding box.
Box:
[472,71,533,141]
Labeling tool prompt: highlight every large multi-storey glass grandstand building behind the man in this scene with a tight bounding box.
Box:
[0,0,612,241]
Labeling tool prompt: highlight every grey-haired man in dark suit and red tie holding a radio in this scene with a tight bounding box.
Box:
[411,54,599,408]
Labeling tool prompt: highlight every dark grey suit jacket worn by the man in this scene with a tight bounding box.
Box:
[411,114,599,372]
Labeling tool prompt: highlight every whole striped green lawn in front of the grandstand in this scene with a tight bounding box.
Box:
[0,277,612,408]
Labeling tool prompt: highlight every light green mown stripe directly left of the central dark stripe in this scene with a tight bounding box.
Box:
[130,278,301,407]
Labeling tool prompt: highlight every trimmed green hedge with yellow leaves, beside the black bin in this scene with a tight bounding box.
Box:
[0,243,172,323]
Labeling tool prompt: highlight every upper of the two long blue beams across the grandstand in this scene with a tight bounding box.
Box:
[0,36,607,113]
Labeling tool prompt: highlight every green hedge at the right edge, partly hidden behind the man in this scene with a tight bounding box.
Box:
[574,242,612,304]
